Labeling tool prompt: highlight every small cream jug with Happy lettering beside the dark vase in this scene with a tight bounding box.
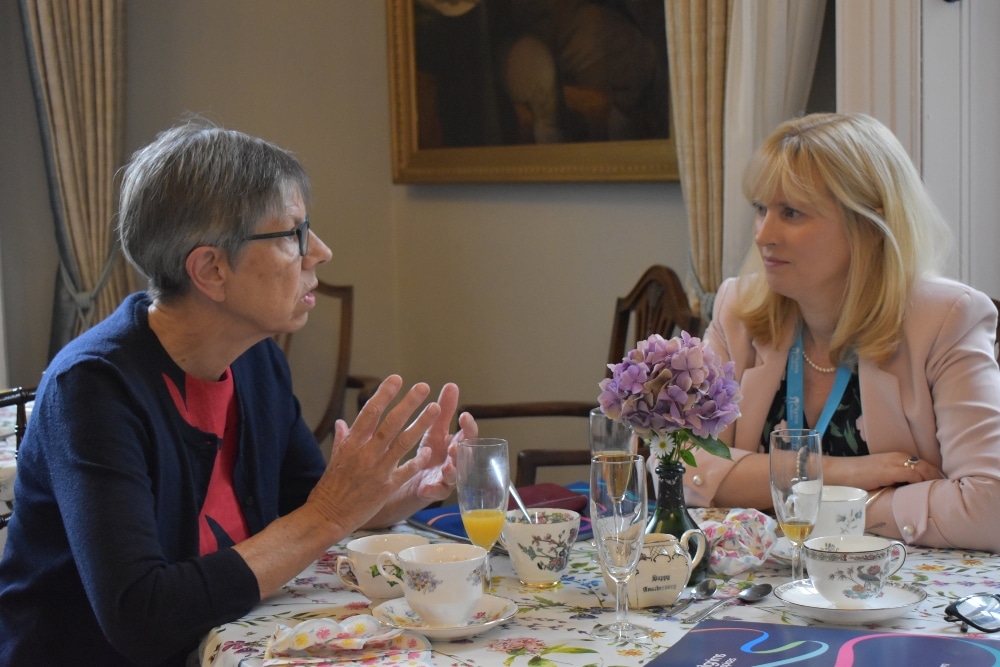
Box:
[604,529,707,608]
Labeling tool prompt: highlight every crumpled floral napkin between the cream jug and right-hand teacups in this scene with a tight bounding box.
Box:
[700,509,778,575]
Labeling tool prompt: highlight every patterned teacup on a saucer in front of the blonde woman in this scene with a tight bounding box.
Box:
[802,535,906,609]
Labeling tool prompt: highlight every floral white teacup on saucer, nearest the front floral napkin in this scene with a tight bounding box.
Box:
[375,542,486,628]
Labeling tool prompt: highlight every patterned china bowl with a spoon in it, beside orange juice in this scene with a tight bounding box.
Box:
[500,507,580,588]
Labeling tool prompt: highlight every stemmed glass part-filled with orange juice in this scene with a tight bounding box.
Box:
[455,438,510,591]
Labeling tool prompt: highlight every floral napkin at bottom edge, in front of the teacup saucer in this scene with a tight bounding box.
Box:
[263,614,433,667]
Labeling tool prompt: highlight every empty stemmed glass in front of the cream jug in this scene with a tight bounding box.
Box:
[590,452,651,641]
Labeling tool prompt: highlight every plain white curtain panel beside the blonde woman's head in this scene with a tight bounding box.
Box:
[722,0,826,276]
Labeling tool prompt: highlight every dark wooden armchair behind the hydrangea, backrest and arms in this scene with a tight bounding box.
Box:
[459,264,702,487]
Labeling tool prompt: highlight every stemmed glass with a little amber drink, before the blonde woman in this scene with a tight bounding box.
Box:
[771,429,823,581]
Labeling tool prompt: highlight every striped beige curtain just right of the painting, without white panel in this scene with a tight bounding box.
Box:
[666,0,733,317]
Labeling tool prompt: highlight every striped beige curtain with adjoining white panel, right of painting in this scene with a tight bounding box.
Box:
[665,0,826,319]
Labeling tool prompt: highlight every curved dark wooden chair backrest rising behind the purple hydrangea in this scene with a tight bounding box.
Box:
[608,264,702,370]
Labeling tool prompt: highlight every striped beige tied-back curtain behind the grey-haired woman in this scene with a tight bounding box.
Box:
[20,0,135,354]
